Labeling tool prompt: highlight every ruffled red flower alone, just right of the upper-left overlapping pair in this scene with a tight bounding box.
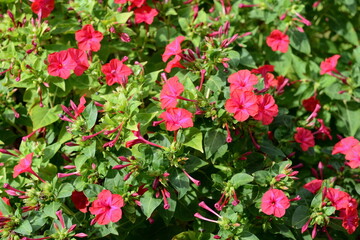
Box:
[101,59,133,86]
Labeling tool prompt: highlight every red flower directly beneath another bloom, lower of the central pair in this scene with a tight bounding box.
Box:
[159,108,194,131]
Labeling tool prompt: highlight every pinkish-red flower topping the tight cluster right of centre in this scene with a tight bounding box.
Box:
[228,70,258,91]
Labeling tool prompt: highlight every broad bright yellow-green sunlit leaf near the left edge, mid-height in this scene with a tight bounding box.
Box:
[30,105,62,130]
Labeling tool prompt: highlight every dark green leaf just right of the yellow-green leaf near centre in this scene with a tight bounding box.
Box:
[204,129,226,159]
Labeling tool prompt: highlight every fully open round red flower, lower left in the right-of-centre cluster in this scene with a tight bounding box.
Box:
[225,89,259,122]
